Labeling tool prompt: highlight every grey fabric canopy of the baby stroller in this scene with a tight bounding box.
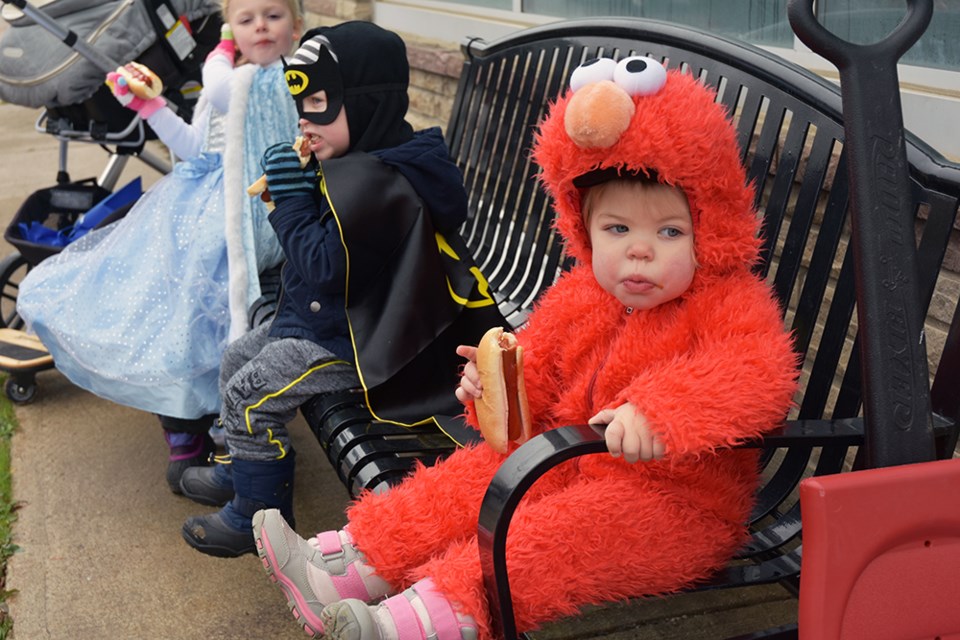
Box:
[0,0,220,107]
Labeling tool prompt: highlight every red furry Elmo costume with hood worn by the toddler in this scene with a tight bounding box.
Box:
[349,60,796,638]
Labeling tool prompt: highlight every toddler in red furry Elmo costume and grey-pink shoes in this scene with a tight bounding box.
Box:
[253,57,797,640]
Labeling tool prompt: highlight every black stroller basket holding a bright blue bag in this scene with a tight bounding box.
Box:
[4,177,143,266]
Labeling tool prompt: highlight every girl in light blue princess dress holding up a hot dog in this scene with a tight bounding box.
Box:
[17,0,302,493]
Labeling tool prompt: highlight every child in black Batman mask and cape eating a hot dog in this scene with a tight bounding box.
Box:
[181,22,502,557]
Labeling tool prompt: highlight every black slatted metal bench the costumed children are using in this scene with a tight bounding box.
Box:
[294,12,960,638]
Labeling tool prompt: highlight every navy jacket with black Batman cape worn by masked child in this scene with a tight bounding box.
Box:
[270,128,502,420]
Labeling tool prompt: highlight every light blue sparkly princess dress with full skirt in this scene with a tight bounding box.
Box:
[17,62,297,419]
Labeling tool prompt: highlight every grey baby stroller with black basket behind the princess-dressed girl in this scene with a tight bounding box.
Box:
[0,0,221,403]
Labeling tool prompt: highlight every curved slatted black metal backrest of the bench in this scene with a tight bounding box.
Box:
[447,18,960,432]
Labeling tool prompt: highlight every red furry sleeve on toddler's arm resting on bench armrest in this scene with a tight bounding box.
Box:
[616,275,797,455]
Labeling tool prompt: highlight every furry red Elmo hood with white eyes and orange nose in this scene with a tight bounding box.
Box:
[534,56,759,291]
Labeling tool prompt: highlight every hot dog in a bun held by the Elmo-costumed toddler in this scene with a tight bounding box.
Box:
[474,327,531,453]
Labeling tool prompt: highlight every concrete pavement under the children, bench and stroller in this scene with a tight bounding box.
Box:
[0,104,796,640]
